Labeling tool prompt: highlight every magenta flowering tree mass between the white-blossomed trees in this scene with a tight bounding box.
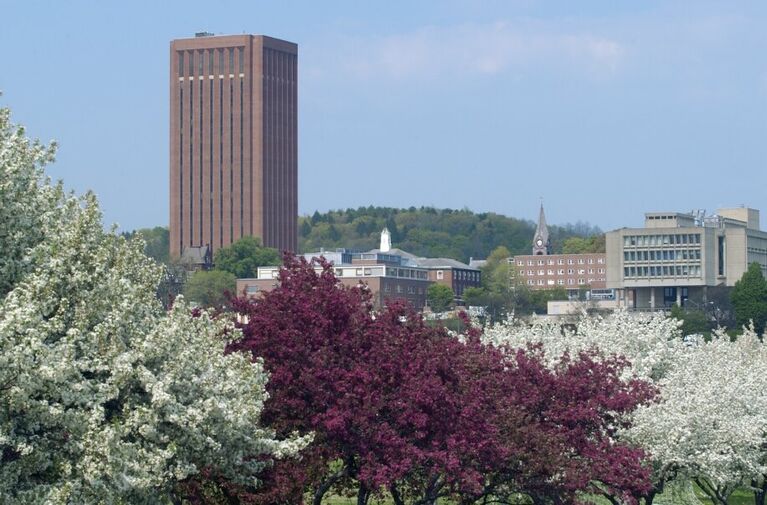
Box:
[225,257,653,505]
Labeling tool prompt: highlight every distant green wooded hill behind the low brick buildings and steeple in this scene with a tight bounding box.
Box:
[298,206,602,262]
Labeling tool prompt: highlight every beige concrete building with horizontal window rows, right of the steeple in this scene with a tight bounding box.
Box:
[606,208,767,309]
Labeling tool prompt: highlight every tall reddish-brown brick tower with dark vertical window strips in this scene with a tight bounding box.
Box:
[170,33,298,257]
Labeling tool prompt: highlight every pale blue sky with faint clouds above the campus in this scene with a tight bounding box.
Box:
[0,0,767,230]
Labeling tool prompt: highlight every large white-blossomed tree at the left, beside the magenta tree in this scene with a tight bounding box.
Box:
[0,104,311,504]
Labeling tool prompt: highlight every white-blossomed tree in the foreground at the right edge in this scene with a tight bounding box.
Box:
[625,328,767,504]
